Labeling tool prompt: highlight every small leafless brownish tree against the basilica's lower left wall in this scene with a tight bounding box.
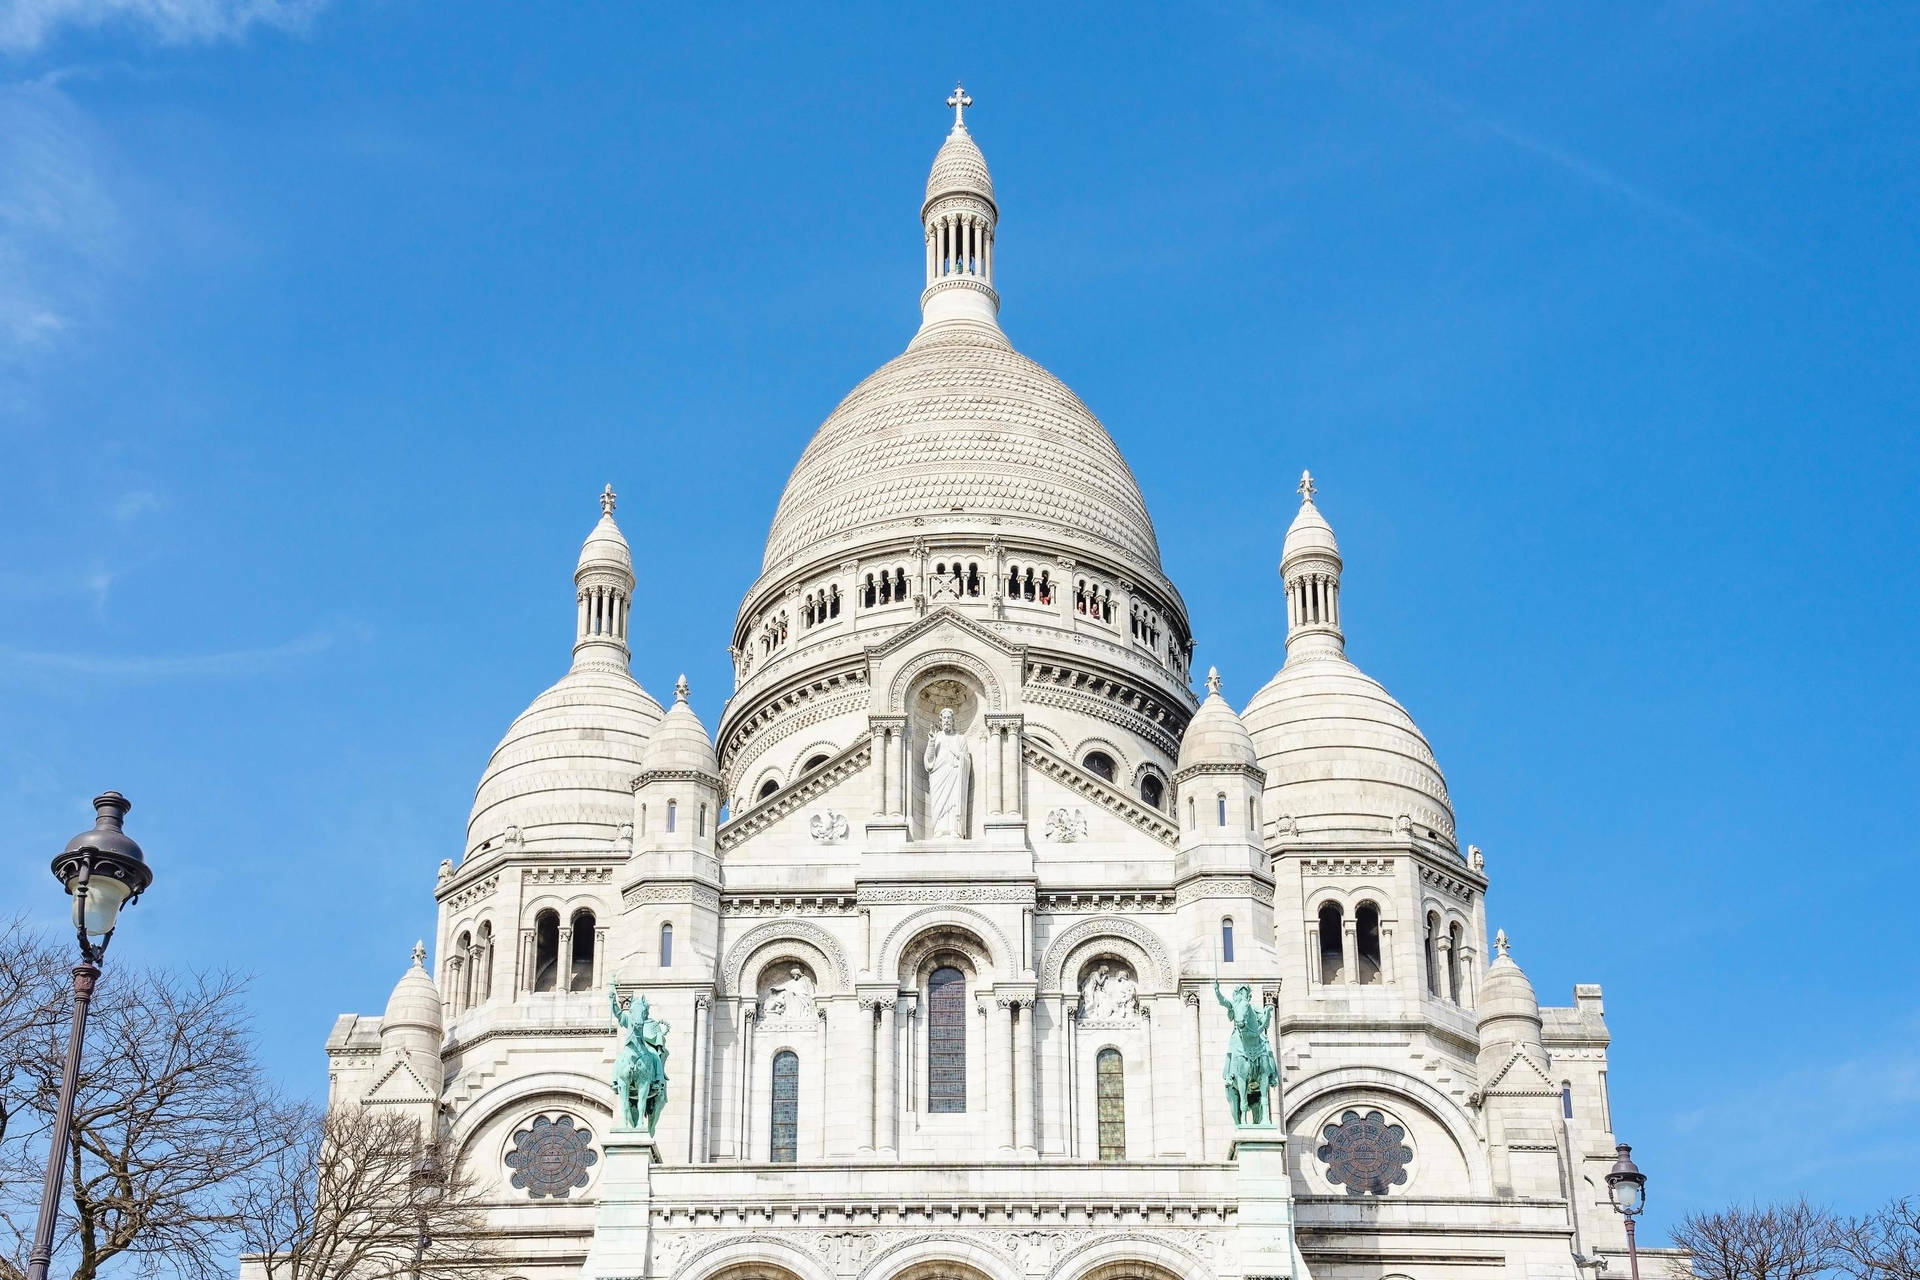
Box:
[240,1107,503,1280]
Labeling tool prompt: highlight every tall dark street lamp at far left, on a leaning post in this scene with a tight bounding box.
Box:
[27,791,154,1280]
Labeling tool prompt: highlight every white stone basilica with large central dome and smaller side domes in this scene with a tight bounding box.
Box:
[326,92,1651,1280]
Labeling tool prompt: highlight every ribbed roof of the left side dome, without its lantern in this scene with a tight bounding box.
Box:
[467,662,660,854]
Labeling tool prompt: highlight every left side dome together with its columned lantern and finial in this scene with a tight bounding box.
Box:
[467,486,660,858]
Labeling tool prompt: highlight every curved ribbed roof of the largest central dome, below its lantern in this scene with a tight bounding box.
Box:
[764,322,1160,572]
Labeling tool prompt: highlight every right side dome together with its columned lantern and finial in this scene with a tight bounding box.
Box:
[1242,472,1457,852]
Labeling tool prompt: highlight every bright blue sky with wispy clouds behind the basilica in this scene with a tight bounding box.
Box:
[0,0,1920,1234]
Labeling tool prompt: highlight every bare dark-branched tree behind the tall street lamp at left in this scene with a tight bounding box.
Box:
[0,967,288,1280]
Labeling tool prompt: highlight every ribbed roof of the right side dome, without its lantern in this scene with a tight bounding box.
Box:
[1240,652,1453,839]
